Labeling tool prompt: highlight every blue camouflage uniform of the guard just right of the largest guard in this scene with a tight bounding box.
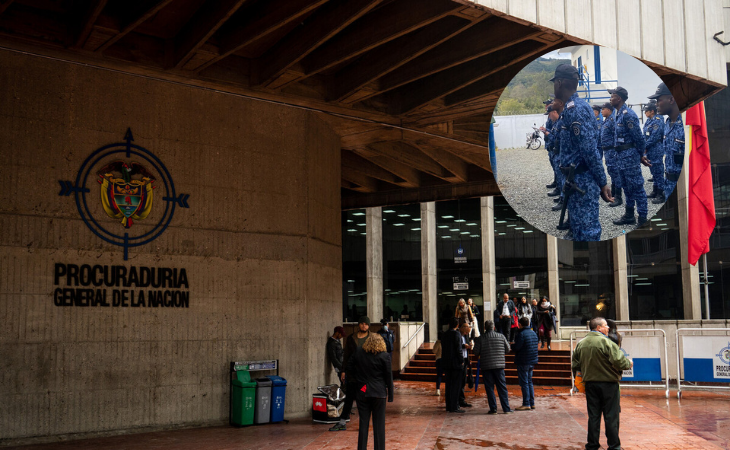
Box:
[614,105,649,217]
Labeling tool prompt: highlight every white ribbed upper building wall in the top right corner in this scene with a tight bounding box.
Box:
[465,0,730,85]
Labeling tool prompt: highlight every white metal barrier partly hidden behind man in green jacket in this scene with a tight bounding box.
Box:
[570,328,669,398]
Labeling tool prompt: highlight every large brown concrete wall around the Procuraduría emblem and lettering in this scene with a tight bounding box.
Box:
[0,52,342,443]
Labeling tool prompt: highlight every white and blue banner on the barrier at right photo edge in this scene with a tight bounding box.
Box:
[681,336,730,383]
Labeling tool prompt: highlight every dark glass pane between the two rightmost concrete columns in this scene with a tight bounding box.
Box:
[626,190,684,320]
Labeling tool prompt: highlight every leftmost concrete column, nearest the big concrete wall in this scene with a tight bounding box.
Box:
[364,207,383,322]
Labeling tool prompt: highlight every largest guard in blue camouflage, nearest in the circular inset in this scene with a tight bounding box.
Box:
[550,64,613,241]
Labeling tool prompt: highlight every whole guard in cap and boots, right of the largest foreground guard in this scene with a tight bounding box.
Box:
[608,86,649,226]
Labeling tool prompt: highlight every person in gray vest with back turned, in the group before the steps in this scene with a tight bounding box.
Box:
[474,320,512,414]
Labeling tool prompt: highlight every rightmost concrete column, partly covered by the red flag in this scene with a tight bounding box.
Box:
[676,113,702,320]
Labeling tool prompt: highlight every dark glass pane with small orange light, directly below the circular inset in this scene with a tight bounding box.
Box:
[558,239,616,327]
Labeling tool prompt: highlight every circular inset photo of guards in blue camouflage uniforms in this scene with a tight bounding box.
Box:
[493,45,684,241]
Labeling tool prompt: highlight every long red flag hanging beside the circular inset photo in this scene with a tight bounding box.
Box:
[686,102,715,265]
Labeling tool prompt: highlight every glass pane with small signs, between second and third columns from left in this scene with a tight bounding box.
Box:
[436,198,484,329]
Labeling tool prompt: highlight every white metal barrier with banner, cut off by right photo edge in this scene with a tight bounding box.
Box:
[676,328,730,398]
